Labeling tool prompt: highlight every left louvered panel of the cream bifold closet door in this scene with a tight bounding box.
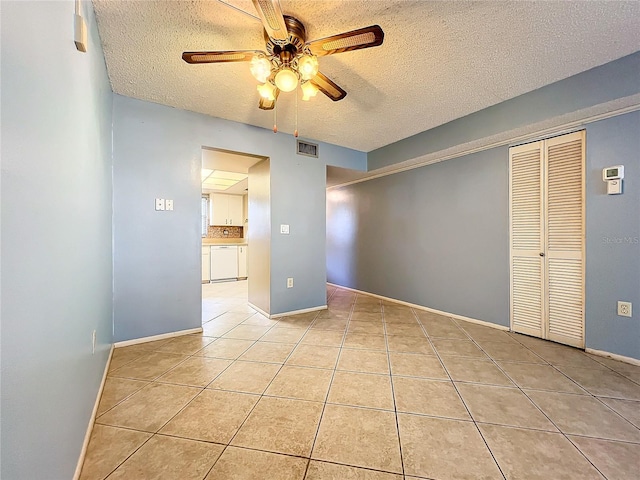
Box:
[509,142,544,337]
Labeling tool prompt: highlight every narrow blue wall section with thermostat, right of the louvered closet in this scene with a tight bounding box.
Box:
[586,112,640,358]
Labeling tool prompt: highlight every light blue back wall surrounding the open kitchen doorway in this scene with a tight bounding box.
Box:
[113,95,366,341]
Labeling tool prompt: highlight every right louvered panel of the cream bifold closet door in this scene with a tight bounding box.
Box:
[545,132,584,348]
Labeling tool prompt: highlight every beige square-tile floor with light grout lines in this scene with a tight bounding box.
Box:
[81,282,640,480]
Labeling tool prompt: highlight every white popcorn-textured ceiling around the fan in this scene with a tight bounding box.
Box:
[93,0,640,152]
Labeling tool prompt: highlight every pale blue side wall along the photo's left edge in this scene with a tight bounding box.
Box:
[0,1,112,480]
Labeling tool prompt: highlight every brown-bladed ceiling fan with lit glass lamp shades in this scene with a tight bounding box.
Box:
[182,0,384,110]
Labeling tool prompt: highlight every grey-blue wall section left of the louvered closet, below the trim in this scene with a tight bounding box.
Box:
[327,147,509,325]
